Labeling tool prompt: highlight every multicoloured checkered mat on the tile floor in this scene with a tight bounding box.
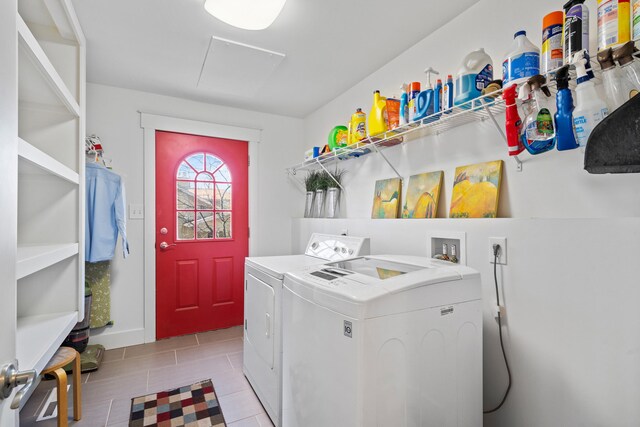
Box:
[129,380,226,427]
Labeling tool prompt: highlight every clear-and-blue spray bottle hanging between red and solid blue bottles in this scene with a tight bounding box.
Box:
[522,74,556,154]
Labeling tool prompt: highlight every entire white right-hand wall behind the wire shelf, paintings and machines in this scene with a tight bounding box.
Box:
[302,0,640,427]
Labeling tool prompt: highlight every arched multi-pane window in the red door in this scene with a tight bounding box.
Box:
[176,153,232,241]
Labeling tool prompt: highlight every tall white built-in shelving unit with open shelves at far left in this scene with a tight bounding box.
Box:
[0,0,86,413]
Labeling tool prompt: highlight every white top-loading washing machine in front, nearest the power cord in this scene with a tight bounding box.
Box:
[282,256,482,427]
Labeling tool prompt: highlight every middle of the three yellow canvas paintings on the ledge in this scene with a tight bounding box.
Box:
[402,171,444,218]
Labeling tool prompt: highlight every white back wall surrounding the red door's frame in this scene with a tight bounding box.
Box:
[87,84,302,347]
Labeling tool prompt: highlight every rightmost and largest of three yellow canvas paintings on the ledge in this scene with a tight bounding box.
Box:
[449,160,502,218]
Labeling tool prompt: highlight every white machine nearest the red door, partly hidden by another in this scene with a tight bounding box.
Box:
[243,234,369,426]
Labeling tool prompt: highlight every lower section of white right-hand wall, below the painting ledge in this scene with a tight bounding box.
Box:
[293,218,640,427]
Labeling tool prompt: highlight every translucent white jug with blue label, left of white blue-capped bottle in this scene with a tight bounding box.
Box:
[454,48,493,109]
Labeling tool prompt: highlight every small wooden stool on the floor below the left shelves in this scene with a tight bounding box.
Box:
[42,347,82,427]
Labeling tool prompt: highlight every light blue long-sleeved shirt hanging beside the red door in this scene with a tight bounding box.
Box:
[84,163,129,262]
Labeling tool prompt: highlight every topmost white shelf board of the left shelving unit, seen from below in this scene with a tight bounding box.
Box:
[17,15,80,117]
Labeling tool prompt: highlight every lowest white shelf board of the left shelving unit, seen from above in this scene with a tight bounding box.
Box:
[16,311,78,374]
